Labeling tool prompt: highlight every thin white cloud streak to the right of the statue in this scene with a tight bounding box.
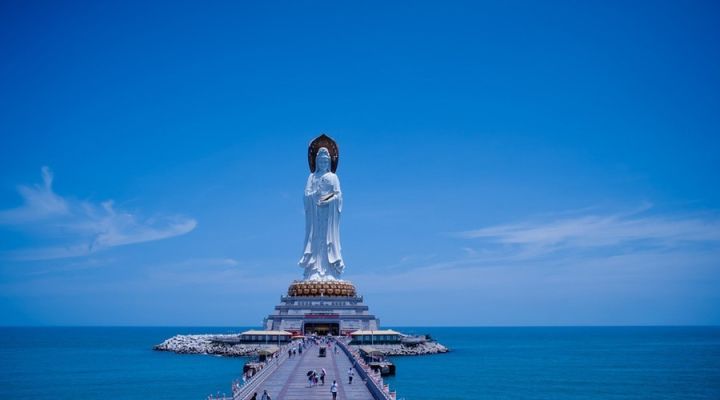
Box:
[386,206,720,274]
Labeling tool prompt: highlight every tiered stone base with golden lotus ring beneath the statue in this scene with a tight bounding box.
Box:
[264,281,380,336]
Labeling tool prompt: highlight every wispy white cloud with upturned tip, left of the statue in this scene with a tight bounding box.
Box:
[0,167,197,260]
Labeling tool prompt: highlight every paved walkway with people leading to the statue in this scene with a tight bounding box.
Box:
[249,345,373,400]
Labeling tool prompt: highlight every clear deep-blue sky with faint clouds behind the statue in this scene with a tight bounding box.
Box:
[0,2,720,326]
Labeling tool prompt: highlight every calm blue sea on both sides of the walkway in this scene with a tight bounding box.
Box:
[0,327,720,400]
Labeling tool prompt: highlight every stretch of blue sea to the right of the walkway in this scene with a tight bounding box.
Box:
[386,327,720,400]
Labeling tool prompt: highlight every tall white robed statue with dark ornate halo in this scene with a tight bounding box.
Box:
[299,135,345,281]
